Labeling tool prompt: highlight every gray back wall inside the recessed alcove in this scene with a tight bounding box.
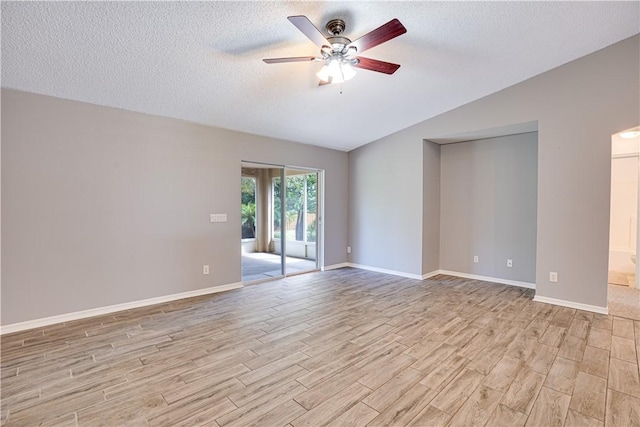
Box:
[440,132,538,283]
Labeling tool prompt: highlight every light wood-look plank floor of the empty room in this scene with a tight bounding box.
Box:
[1,269,640,427]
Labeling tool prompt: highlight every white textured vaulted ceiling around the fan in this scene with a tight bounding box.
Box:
[2,1,640,150]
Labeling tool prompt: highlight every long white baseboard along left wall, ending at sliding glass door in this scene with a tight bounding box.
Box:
[0,283,242,335]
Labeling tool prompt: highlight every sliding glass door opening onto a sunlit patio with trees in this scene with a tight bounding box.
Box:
[241,162,323,283]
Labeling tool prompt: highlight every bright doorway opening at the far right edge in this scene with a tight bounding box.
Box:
[607,127,640,320]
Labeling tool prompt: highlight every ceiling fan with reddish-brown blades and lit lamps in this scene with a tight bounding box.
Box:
[263,15,407,85]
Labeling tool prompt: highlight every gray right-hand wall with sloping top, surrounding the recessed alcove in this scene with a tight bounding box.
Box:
[349,36,640,307]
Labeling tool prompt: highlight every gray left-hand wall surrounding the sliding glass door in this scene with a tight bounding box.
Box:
[1,89,348,325]
